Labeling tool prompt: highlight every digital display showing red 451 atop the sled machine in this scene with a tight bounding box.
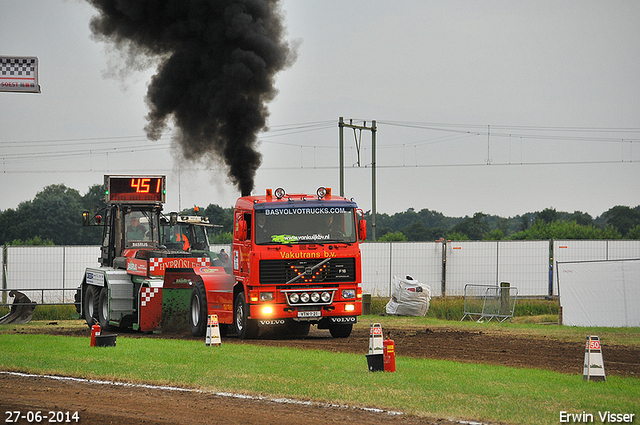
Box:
[104,176,167,203]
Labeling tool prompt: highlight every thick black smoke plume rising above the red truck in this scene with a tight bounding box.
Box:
[87,0,295,195]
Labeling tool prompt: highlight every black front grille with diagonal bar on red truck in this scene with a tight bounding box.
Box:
[260,258,356,285]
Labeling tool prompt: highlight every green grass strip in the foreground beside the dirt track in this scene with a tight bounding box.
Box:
[0,332,640,424]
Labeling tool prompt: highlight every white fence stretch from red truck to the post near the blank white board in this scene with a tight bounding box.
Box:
[362,241,549,297]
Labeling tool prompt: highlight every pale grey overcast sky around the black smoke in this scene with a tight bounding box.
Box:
[0,0,640,217]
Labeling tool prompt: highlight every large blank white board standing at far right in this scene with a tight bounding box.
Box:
[557,259,640,327]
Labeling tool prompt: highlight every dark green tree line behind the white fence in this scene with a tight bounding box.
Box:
[0,184,640,245]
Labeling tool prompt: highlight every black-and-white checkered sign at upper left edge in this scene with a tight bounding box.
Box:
[0,56,40,93]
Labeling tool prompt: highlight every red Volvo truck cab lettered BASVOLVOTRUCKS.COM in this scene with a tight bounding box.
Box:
[226,187,366,337]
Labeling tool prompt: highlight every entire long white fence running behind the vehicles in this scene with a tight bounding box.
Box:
[0,240,640,302]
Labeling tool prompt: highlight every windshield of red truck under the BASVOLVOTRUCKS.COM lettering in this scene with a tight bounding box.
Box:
[255,207,357,245]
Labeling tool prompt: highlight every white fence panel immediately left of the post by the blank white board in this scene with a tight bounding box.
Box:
[496,241,550,296]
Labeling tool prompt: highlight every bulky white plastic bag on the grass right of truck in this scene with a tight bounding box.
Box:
[386,276,431,316]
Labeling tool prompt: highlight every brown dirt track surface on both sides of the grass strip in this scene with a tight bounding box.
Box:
[0,327,640,425]
